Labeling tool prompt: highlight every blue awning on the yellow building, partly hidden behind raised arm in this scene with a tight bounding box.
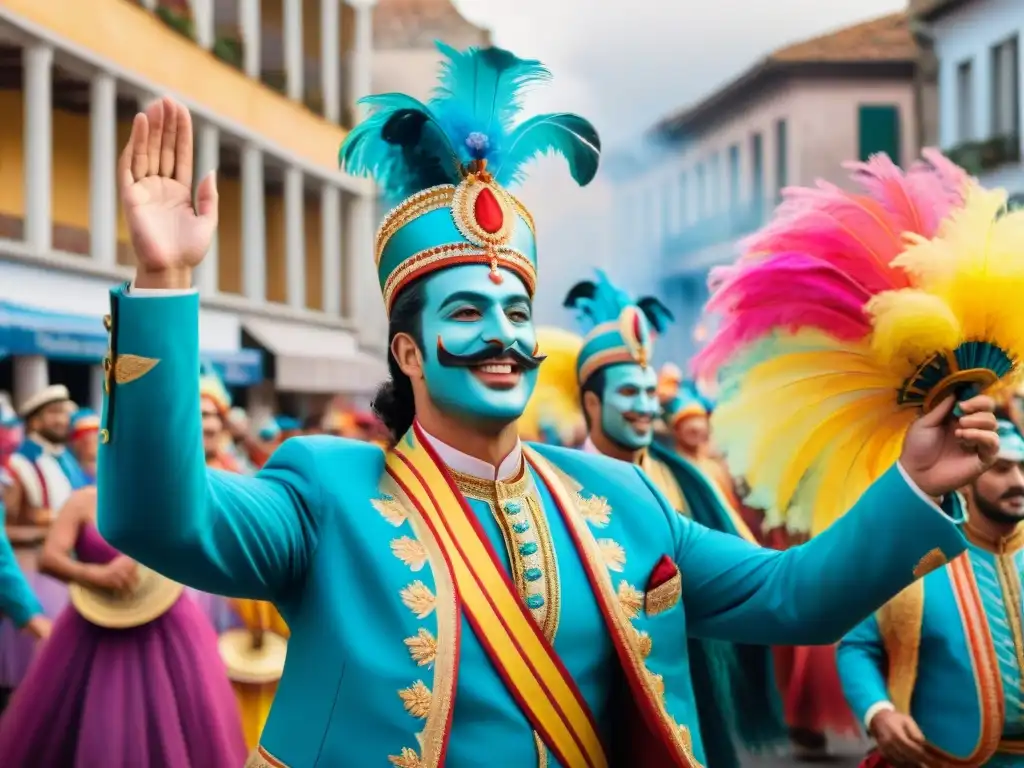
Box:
[0,301,263,387]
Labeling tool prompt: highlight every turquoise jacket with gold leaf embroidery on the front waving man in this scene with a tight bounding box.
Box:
[98,289,965,768]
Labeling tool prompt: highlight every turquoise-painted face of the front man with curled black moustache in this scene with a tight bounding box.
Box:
[423,264,538,422]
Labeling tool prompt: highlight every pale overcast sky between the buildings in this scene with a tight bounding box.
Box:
[453,0,906,322]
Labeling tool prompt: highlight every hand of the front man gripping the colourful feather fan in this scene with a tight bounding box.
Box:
[900,395,999,497]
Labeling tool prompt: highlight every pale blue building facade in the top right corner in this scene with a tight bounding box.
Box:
[911,0,1024,204]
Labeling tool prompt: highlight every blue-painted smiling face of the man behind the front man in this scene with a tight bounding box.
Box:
[601,364,658,451]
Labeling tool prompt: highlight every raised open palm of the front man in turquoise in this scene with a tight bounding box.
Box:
[118,98,217,289]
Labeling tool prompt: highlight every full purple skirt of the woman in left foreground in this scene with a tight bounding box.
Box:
[0,597,247,768]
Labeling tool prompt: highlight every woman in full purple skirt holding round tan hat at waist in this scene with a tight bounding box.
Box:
[0,487,246,768]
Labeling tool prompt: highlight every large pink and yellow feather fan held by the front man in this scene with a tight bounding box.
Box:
[695,152,1024,532]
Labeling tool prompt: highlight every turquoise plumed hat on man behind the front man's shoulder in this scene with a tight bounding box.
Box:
[564,269,673,387]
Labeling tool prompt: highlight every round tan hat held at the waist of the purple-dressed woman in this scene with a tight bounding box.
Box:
[68,565,184,630]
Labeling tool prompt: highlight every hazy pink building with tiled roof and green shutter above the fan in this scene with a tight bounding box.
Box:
[610,14,918,361]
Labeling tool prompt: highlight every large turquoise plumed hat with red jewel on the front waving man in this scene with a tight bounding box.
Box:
[339,43,601,313]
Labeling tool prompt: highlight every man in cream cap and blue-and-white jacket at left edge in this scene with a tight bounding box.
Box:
[0,384,89,697]
